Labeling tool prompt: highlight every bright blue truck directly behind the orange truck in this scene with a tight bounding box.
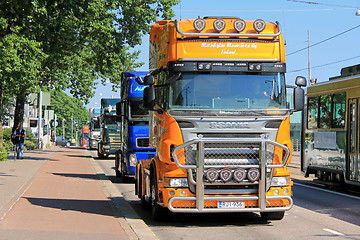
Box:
[115,72,155,178]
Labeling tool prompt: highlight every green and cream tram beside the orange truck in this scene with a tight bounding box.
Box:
[301,64,360,185]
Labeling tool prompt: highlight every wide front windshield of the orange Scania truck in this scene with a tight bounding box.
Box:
[169,73,286,110]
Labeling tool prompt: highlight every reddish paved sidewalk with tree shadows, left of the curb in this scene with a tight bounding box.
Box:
[0,147,137,240]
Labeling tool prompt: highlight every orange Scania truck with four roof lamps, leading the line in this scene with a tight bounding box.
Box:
[135,17,306,220]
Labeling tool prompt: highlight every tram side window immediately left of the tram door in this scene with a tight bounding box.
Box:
[331,93,346,128]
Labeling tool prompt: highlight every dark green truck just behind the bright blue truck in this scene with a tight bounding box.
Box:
[98,98,121,158]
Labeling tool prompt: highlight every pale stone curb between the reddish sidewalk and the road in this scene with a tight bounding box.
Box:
[88,156,158,240]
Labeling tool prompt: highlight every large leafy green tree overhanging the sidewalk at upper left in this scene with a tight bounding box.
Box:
[0,0,177,146]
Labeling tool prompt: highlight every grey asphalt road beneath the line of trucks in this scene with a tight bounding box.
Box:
[89,151,360,240]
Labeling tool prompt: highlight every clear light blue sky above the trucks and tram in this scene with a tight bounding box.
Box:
[86,0,360,108]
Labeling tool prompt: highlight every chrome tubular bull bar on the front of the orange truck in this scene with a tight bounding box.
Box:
[168,138,293,213]
